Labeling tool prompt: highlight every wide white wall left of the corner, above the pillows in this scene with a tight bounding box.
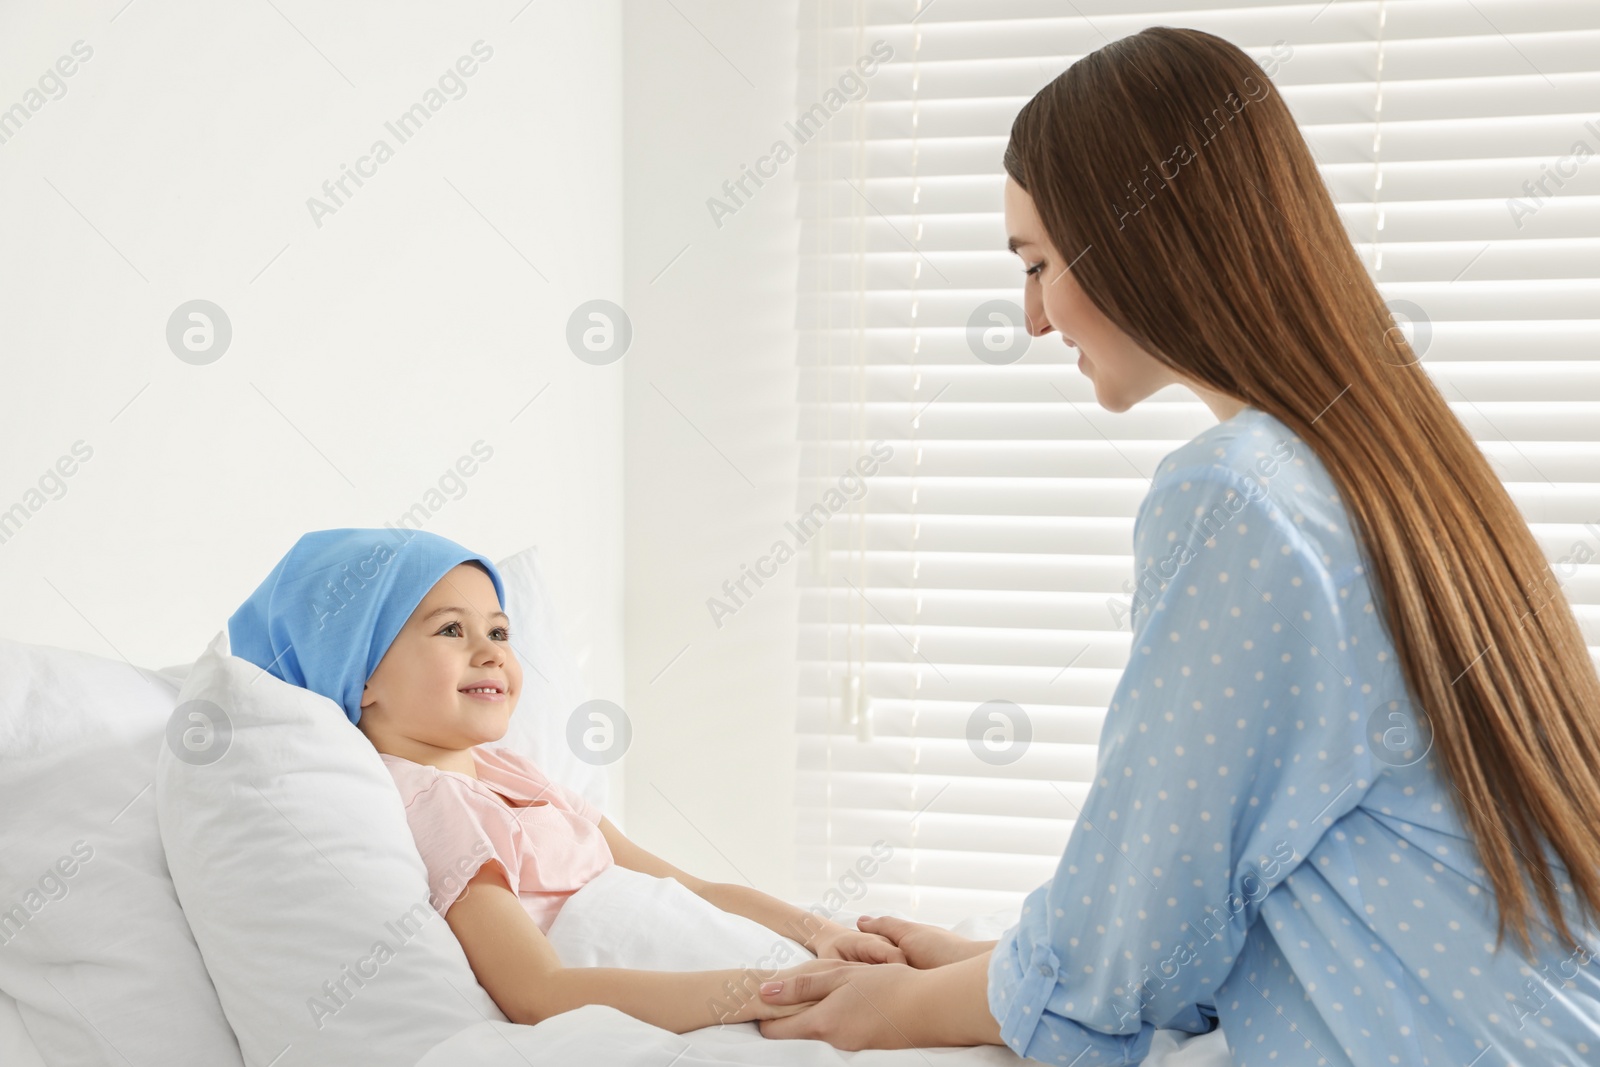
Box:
[0,0,624,797]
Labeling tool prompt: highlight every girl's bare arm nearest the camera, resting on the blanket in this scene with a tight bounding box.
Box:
[445,864,842,1033]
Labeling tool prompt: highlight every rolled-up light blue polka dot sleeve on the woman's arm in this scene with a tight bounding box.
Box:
[989,467,1371,1067]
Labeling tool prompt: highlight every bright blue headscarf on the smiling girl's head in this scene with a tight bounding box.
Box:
[227,528,506,723]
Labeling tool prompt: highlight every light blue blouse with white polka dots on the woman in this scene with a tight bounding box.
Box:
[989,406,1600,1067]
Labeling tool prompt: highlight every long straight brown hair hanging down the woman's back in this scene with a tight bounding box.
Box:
[1005,26,1600,955]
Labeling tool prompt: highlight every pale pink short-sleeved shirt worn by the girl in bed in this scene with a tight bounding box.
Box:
[379,745,613,933]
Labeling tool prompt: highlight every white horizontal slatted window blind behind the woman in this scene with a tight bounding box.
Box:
[797,0,1600,921]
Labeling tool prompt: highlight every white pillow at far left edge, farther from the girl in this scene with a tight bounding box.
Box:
[0,640,242,1067]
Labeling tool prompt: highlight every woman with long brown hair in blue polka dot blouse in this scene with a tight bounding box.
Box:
[762,27,1600,1067]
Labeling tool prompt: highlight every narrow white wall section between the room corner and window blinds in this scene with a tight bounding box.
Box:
[622,0,798,897]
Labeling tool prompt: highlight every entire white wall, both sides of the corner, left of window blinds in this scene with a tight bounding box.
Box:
[0,0,798,896]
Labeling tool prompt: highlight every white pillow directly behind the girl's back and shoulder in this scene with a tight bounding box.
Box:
[155,630,504,1067]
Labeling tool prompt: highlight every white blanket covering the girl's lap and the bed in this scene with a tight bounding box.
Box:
[416,867,1232,1067]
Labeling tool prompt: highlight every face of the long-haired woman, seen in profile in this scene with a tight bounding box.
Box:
[1005,176,1182,411]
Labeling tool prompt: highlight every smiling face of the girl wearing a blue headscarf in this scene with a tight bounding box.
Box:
[357,563,522,760]
